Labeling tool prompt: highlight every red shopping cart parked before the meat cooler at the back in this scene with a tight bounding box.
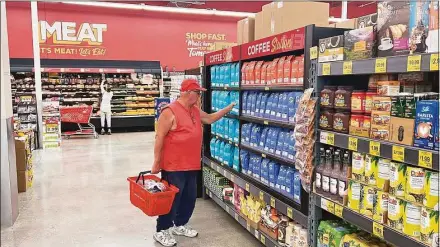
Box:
[60,106,99,139]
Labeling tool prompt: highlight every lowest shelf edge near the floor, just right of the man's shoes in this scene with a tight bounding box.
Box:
[205,188,281,247]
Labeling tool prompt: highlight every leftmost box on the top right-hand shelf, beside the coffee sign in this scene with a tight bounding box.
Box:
[318,35,344,63]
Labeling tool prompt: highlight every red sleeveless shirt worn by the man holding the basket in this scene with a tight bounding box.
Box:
[161,101,202,171]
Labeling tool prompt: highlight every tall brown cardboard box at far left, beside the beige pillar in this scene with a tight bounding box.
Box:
[15,135,34,192]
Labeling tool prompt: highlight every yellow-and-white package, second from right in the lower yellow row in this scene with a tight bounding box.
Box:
[403,202,422,239]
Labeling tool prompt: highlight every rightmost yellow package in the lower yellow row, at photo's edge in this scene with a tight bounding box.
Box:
[420,207,439,246]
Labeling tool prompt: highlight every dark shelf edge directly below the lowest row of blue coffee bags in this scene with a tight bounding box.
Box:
[203,156,308,228]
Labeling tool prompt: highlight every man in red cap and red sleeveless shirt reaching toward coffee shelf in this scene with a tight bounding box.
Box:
[151,79,235,246]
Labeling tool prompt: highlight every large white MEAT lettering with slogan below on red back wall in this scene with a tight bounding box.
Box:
[39,21,107,57]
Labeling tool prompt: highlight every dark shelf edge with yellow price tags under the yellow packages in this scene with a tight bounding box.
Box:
[312,193,428,247]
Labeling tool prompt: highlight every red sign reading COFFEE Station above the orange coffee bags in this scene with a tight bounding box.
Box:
[241,28,304,60]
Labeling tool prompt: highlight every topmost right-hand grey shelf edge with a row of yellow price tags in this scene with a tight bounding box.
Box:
[318,53,438,76]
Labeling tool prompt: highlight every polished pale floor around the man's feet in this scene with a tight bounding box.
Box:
[1,132,260,247]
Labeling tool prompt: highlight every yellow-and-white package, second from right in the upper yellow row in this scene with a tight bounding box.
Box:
[405,166,425,204]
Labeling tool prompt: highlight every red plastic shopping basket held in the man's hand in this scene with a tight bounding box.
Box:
[127,171,179,216]
